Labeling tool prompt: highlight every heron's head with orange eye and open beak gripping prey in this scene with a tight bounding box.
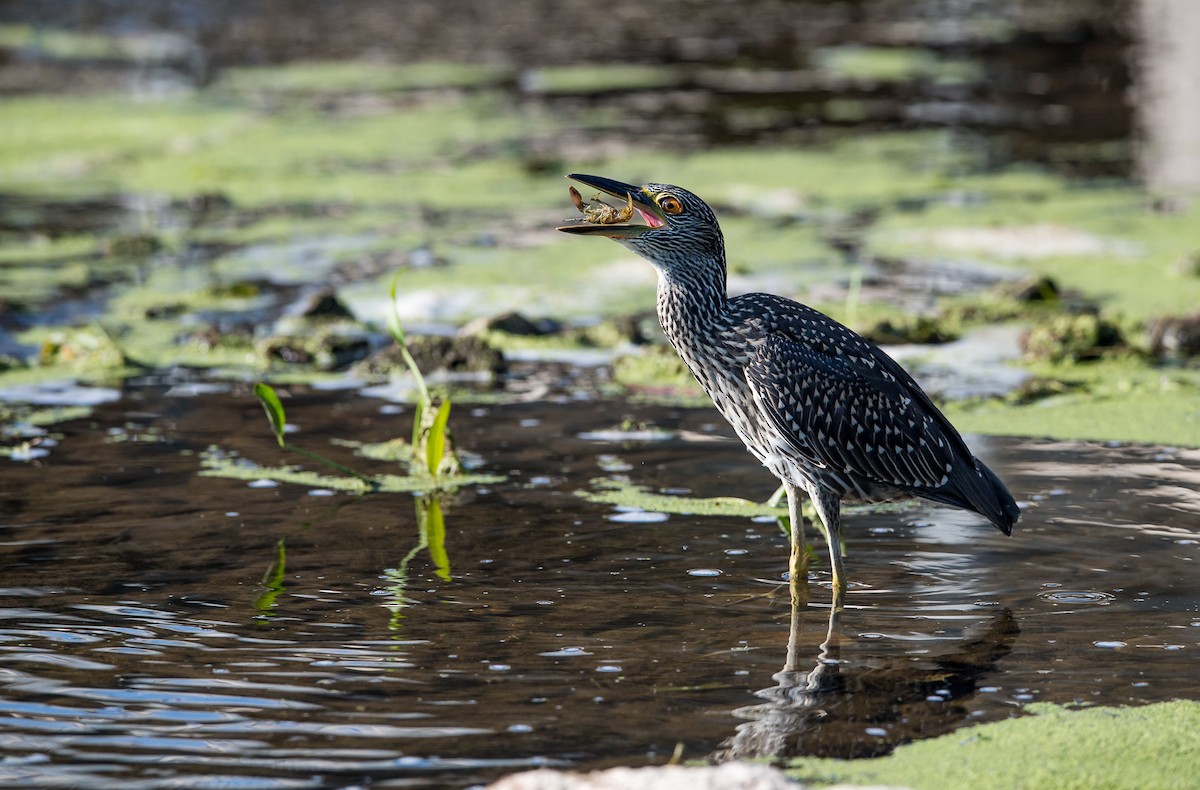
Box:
[558,173,725,275]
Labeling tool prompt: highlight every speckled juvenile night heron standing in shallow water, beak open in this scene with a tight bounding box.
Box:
[558,174,1020,597]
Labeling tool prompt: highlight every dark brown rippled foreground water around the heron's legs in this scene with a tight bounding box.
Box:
[0,385,1200,788]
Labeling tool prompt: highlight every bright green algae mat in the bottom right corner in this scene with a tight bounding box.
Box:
[787,700,1200,790]
